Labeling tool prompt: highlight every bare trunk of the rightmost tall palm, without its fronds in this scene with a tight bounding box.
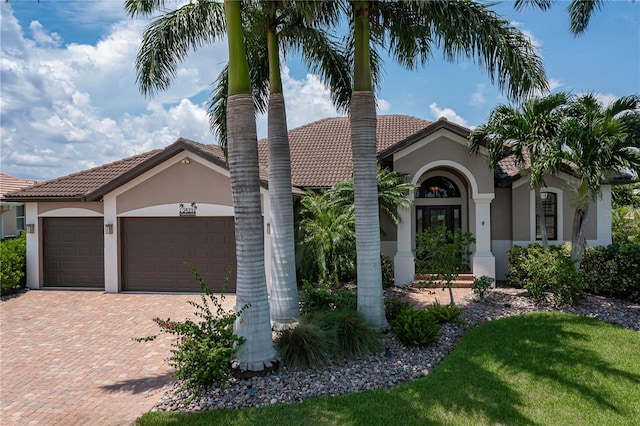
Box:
[351,2,387,329]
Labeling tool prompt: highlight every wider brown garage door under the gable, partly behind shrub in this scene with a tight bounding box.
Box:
[121,217,236,292]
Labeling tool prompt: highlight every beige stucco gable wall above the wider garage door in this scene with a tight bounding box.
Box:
[117,161,233,214]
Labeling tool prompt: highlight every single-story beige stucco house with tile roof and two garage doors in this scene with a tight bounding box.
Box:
[7,115,611,292]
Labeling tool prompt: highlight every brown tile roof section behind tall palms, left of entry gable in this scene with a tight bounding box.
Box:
[258,115,431,188]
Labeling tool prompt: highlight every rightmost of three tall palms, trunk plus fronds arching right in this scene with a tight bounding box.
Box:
[342,0,547,328]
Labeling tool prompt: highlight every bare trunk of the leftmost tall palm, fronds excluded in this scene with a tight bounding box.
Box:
[224,0,277,371]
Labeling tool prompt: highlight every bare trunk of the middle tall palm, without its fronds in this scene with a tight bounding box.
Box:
[267,24,300,329]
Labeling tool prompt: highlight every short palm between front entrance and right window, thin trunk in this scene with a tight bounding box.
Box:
[469,92,569,247]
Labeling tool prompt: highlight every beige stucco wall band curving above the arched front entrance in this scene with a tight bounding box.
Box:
[393,131,494,193]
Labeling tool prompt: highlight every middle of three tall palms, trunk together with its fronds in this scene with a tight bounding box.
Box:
[209,1,351,329]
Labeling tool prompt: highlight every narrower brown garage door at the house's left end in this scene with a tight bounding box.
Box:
[42,217,104,288]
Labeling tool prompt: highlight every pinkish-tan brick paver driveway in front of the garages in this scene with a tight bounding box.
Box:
[0,290,235,426]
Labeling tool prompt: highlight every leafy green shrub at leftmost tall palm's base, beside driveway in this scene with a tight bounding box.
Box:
[135,265,249,396]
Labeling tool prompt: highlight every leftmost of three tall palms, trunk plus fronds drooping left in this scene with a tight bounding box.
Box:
[125,0,277,371]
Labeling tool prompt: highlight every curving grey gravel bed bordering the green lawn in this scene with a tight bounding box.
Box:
[152,288,640,411]
